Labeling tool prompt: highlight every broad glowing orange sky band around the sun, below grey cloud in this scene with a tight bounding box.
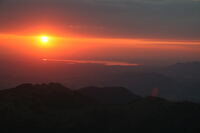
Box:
[0,34,200,64]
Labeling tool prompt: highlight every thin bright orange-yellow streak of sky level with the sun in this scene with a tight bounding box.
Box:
[0,34,200,46]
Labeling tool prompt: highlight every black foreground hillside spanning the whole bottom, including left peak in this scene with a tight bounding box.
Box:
[0,83,200,133]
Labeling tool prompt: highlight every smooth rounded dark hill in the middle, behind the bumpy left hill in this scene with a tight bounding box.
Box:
[78,87,141,104]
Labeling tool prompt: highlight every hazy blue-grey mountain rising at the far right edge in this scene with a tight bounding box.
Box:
[159,62,200,102]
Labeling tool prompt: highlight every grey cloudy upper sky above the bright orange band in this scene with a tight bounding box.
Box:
[0,0,200,40]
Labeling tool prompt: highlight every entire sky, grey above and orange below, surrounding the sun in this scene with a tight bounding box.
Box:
[0,0,200,64]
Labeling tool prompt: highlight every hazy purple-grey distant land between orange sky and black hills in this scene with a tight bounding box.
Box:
[0,62,200,102]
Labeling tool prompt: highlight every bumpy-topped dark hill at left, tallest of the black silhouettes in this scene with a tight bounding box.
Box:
[0,83,93,107]
